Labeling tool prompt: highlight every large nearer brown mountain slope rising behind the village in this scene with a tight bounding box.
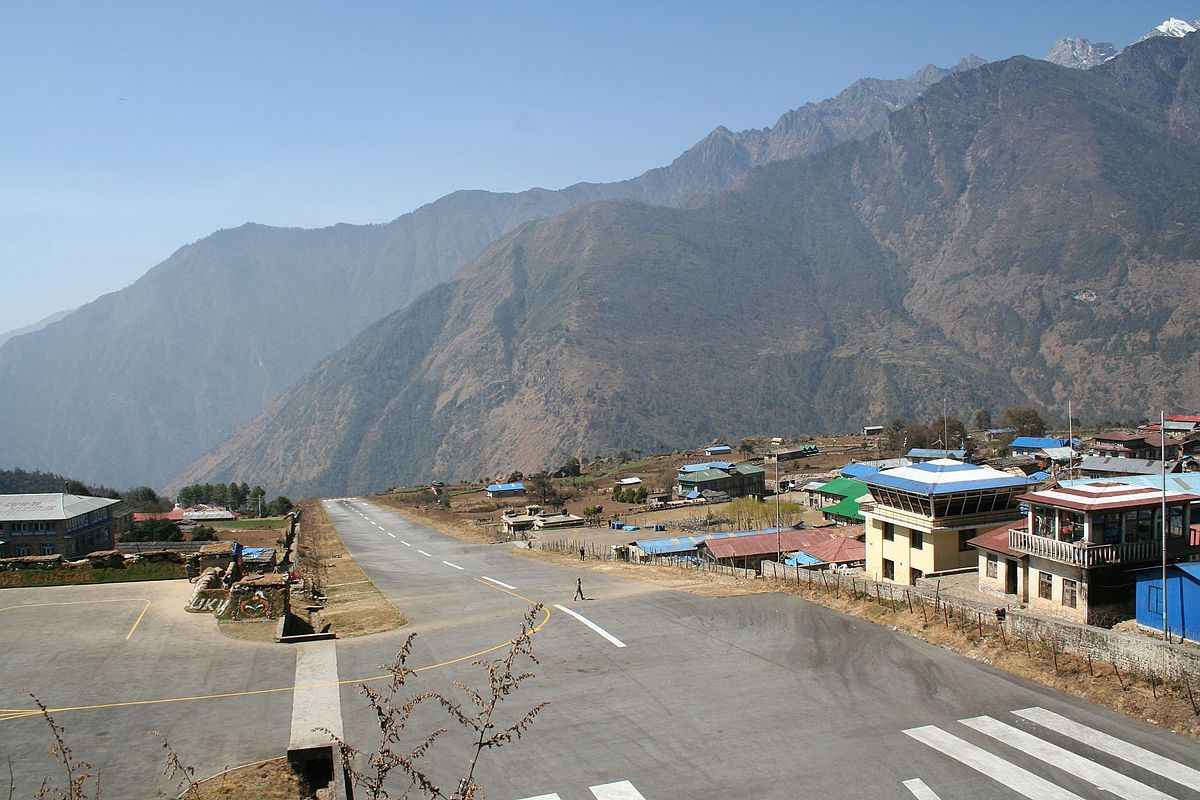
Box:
[179,35,1200,494]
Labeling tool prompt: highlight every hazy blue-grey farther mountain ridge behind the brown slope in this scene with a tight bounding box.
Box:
[0,58,980,486]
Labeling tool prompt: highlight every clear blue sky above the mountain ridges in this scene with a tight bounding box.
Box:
[0,0,1185,331]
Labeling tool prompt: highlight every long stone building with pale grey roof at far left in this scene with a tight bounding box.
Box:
[0,492,133,558]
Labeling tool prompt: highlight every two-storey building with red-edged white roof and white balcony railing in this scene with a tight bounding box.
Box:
[972,481,1200,625]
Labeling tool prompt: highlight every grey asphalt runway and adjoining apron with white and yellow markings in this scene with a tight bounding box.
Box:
[0,499,1200,800]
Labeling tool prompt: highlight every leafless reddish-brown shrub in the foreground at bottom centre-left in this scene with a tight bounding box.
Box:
[325,603,547,800]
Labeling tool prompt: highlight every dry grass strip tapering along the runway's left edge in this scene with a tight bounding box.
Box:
[300,500,408,638]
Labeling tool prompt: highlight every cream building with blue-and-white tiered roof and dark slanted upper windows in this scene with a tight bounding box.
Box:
[859,458,1030,585]
